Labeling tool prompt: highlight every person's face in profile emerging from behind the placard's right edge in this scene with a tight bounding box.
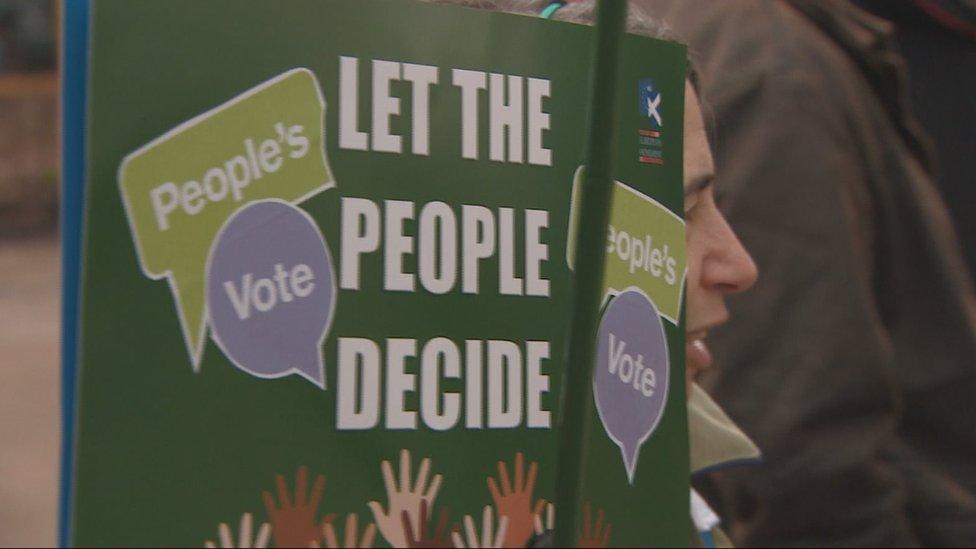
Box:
[684,82,758,390]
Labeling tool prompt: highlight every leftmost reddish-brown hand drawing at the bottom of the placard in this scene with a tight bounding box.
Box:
[261,465,325,547]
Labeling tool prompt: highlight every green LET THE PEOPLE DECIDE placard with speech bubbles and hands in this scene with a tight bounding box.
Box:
[69,0,691,546]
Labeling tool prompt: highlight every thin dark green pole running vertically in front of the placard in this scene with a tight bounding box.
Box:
[555,0,627,547]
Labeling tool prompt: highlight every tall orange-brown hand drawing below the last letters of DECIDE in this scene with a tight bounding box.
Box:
[488,452,543,547]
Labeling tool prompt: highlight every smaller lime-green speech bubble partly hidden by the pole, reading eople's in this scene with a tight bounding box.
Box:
[566,167,687,325]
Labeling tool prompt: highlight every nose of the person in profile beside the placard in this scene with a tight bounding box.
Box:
[702,214,759,294]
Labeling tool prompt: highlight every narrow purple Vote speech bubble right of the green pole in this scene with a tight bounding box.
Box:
[593,287,670,484]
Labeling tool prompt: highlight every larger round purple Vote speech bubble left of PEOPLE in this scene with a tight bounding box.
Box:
[206,200,336,389]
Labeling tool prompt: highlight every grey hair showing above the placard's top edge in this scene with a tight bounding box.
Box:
[425,0,674,40]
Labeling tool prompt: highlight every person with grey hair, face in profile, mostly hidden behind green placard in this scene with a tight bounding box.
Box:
[428,0,759,547]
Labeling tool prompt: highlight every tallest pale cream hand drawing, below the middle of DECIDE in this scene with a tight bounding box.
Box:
[369,450,442,547]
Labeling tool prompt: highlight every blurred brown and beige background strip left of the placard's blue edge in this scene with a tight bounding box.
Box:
[0,0,60,547]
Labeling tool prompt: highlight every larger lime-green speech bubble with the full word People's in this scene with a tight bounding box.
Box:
[119,68,335,370]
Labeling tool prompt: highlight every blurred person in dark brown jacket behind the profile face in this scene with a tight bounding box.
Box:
[636,0,976,547]
